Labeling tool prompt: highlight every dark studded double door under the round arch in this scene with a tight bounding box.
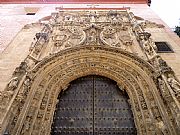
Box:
[51,75,136,135]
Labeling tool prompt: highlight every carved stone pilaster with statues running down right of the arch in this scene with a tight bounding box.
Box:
[130,11,180,130]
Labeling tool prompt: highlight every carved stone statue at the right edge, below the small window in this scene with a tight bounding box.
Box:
[167,74,180,96]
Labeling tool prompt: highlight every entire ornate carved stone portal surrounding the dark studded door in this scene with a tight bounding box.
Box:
[0,10,180,135]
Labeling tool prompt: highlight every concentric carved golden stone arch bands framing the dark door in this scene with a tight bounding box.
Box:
[1,46,174,135]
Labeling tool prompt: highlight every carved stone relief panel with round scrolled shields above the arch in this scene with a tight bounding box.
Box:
[30,10,136,57]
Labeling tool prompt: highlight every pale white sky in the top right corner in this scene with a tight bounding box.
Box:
[151,0,180,28]
